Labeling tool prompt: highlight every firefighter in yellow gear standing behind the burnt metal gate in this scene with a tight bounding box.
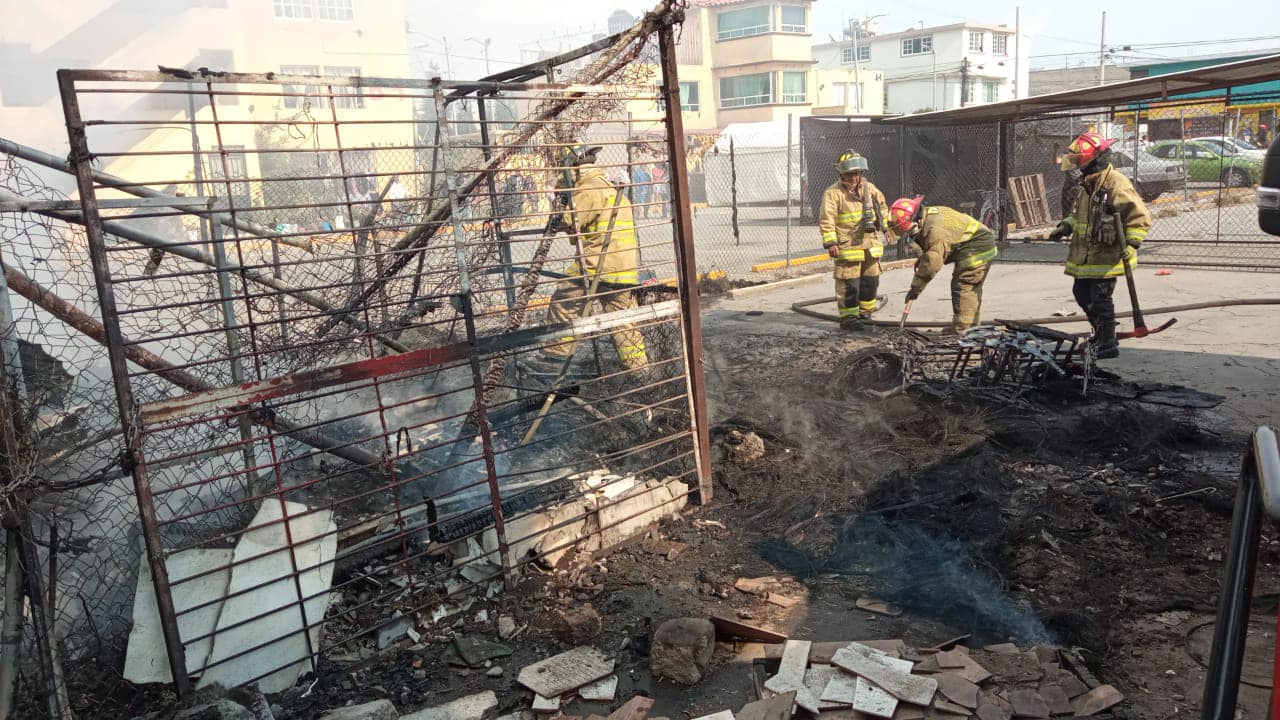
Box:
[543,146,649,369]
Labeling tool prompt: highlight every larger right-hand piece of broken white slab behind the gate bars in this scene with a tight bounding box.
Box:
[200,498,338,693]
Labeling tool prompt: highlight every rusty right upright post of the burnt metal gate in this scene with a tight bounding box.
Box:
[658,24,714,503]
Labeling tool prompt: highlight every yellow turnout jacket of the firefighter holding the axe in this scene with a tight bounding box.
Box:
[1064,165,1151,279]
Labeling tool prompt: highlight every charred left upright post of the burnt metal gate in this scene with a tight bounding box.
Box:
[58,70,191,698]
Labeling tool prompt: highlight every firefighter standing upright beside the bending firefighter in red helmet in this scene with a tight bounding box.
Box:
[818,150,888,329]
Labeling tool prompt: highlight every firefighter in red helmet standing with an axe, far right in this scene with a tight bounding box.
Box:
[1050,132,1151,359]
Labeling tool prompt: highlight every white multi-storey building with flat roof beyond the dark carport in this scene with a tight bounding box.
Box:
[813,23,1029,114]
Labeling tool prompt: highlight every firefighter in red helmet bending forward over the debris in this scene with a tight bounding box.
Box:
[890,196,997,334]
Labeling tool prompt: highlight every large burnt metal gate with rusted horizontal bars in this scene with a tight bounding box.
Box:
[59,26,710,693]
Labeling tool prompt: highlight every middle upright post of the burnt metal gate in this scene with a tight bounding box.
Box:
[435,86,516,591]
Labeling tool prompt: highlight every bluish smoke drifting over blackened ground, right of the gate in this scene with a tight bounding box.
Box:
[756,515,1053,644]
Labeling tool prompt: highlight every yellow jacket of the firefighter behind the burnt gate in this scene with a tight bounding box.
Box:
[564,165,640,284]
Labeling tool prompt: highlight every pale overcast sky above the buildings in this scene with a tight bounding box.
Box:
[406,0,1280,78]
